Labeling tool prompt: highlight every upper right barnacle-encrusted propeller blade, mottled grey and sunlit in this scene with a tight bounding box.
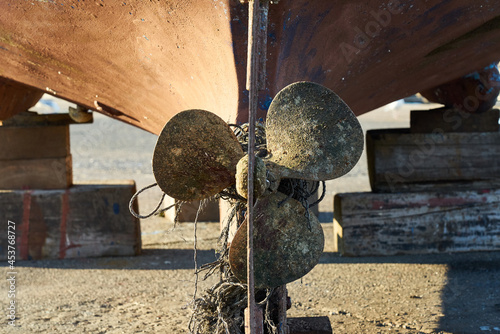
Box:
[266,82,363,181]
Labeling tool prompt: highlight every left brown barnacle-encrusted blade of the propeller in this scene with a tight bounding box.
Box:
[153,110,244,201]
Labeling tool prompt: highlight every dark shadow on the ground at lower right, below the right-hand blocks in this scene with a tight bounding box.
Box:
[320,252,500,334]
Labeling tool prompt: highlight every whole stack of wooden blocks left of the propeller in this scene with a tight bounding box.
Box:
[0,113,141,260]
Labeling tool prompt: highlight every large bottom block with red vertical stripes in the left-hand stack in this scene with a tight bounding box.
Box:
[0,181,141,260]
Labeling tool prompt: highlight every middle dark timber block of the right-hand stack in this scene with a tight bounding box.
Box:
[366,129,500,192]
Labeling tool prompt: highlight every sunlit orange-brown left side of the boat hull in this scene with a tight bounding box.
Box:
[0,0,238,134]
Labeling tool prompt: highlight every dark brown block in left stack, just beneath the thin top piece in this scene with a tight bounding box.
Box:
[0,125,70,160]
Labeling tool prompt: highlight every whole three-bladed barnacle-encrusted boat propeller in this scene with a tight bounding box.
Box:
[153,82,363,288]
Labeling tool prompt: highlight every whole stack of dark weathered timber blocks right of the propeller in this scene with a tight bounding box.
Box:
[334,108,500,256]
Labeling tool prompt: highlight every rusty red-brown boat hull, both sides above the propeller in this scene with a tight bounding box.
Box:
[0,0,500,134]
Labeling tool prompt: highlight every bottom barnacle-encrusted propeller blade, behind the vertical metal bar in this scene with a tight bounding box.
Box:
[229,192,325,288]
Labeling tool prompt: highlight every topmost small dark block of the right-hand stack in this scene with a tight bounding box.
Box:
[410,108,499,133]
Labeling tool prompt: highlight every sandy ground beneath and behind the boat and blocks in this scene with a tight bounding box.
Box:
[0,97,500,333]
